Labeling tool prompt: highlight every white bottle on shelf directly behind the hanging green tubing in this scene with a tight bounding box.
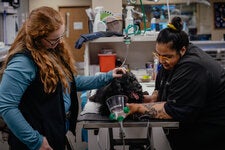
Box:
[125,6,134,34]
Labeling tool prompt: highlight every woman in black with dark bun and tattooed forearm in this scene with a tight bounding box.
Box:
[127,17,225,150]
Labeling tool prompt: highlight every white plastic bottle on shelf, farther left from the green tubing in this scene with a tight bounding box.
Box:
[93,6,107,32]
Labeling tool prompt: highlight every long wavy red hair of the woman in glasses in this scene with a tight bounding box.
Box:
[0,6,77,93]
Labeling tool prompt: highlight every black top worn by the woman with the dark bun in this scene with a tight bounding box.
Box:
[156,44,225,126]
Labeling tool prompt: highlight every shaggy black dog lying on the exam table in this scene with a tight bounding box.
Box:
[89,72,147,116]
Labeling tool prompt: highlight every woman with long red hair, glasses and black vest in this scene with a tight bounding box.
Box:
[0,7,126,150]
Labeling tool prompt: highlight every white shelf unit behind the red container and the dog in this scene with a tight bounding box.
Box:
[84,36,156,75]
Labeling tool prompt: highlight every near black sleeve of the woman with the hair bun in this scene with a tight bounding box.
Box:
[165,63,209,120]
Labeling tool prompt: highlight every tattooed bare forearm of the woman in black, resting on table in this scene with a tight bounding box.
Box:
[143,102,172,119]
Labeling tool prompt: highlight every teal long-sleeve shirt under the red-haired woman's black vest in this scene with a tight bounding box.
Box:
[0,54,113,150]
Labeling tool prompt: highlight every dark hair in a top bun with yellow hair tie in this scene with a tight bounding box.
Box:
[156,17,189,53]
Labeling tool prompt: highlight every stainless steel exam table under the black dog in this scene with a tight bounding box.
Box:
[78,113,179,150]
